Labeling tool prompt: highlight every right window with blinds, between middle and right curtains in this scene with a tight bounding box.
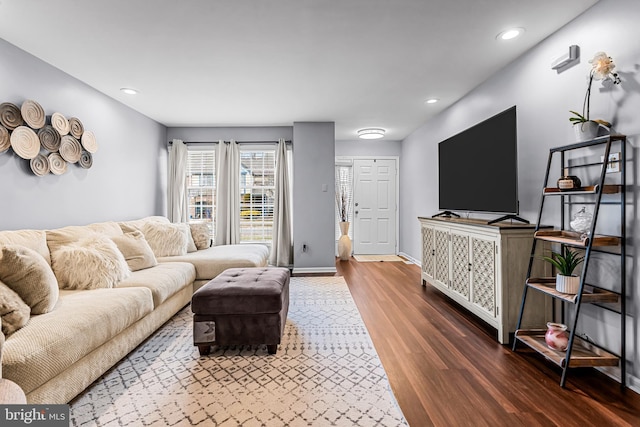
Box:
[240,146,276,245]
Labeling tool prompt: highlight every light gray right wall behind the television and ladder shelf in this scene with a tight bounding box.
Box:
[400,0,640,389]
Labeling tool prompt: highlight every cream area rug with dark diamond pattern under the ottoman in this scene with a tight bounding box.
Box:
[71,277,407,427]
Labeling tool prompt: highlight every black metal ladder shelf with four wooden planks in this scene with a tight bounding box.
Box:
[513,135,626,387]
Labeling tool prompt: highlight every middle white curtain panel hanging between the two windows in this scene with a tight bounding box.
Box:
[216,140,240,245]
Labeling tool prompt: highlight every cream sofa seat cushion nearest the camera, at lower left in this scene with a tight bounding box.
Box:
[2,287,153,394]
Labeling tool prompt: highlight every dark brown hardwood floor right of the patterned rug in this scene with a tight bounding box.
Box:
[336,258,640,427]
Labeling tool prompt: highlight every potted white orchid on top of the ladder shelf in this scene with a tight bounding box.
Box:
[569,52,620,142]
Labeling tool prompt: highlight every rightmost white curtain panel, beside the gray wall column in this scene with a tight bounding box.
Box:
[269,138,293,267]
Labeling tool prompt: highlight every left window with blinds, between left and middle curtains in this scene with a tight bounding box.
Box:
[186,148,216,239]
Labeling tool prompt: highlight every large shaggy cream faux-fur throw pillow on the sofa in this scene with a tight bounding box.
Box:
[51,235,131,289]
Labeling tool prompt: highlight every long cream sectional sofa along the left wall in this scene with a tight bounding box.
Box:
[0,217,268,404]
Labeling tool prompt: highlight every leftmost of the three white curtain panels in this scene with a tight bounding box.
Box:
[167,139,188,222]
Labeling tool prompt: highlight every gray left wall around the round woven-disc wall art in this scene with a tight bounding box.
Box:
[0,39,167,230]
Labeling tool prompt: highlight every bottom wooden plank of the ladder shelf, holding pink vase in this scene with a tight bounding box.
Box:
[515,329,620,368]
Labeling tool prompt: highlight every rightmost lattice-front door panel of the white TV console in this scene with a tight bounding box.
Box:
[471,236,496,317]
